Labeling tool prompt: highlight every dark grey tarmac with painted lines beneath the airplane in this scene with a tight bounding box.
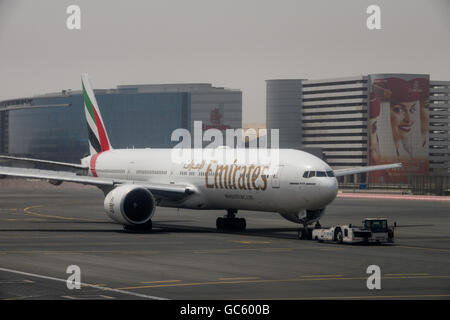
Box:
[0,180,450,300]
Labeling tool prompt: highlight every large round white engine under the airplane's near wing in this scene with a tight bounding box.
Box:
[104,184,156,226]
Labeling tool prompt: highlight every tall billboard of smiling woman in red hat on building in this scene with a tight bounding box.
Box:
[368,74,430,183]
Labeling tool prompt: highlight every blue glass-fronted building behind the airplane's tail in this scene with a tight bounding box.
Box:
[0,83,242,163]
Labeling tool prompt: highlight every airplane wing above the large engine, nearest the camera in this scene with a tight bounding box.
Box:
[0,167,195,200]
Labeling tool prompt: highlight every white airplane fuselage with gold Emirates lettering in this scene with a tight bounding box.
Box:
[83,149,337,222]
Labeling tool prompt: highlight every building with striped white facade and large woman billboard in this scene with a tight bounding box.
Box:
[266,74,450,183]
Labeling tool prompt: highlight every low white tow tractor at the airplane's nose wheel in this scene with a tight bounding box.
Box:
[312,218,396,243]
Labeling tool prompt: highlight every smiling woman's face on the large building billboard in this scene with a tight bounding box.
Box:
[391,101,417,141]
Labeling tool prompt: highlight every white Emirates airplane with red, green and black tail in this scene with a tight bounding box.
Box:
[0,74,401,238]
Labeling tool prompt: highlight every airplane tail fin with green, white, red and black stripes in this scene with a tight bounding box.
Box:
[81,73,112,155]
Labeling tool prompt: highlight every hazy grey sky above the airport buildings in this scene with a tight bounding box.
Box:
[0,0,450,122]
